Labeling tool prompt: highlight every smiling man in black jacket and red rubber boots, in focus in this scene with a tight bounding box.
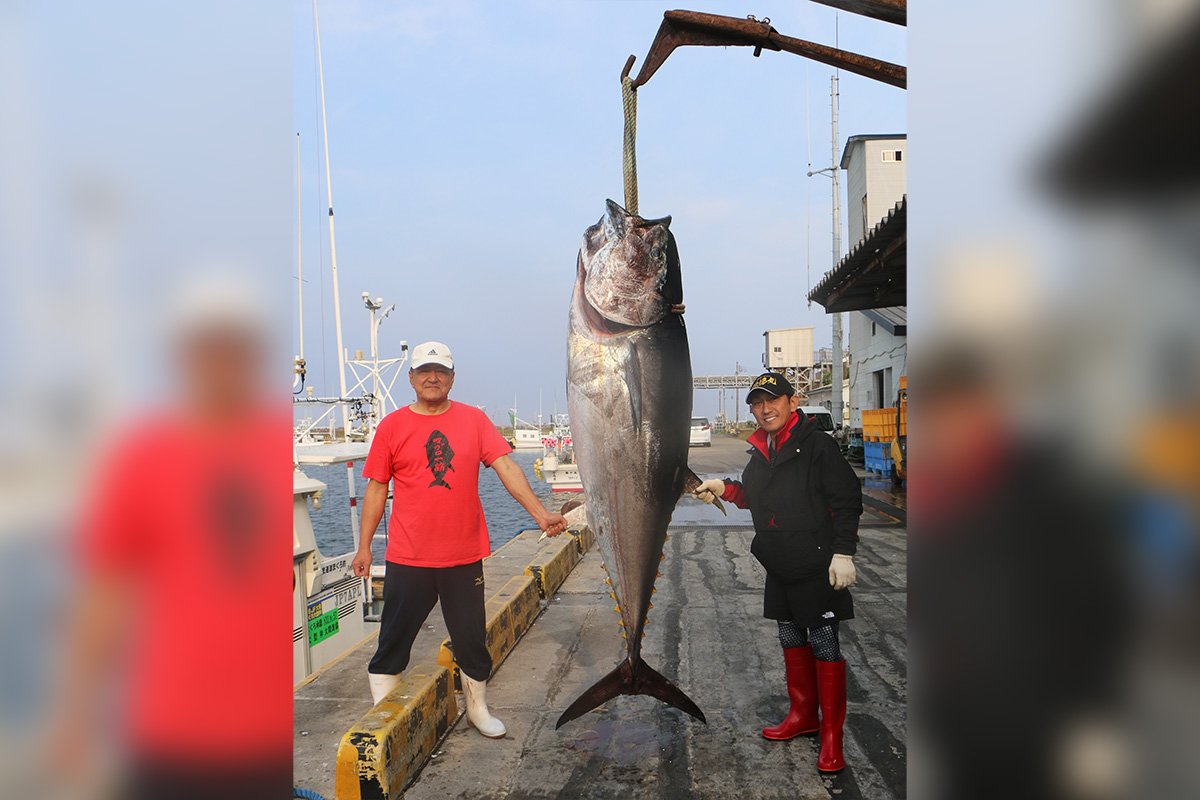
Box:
[694,372,863,772]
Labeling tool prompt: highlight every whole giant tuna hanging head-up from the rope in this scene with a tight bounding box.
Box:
[558,200,704,727]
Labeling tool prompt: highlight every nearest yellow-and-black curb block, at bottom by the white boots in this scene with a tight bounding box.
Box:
[335,666,458,800]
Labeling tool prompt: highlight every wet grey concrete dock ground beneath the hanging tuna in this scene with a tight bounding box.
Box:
[295,435,906,800]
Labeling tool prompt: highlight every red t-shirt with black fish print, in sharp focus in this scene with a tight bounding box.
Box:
[362,402,512,567]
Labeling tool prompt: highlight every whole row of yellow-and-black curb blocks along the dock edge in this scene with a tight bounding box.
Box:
[335,528,595,800]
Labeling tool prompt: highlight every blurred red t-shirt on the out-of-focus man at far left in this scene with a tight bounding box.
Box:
[77,410,292,765]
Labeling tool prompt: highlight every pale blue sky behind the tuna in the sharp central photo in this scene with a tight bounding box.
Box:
[293,0,906,422]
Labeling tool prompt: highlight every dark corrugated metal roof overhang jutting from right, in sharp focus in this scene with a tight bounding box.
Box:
[809,194,908,314]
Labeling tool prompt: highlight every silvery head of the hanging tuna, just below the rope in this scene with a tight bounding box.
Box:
[580,200,683,327]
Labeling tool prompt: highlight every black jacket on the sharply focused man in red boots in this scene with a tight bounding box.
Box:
[726,414,863,582]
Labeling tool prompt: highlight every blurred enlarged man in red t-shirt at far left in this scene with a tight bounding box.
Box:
[61,277,292,800]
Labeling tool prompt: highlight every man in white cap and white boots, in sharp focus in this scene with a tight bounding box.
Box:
[352,342,566,739]
